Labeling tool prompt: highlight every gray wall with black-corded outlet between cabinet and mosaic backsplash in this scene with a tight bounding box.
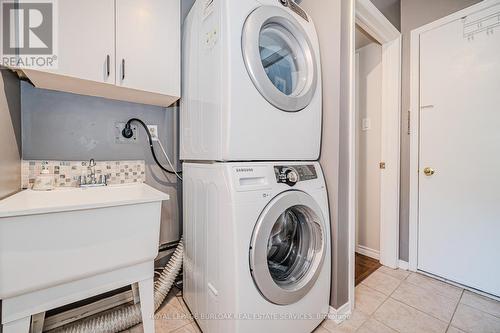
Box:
[21,82,181,243]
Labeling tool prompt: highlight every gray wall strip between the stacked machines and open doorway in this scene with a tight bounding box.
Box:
[301,0,353,308]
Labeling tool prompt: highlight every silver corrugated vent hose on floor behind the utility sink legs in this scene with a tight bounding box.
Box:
[50,239,184,333]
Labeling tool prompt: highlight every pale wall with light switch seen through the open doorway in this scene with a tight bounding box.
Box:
[356,43,382,252]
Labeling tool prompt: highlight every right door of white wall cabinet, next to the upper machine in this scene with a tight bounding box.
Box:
[116,0,181,96]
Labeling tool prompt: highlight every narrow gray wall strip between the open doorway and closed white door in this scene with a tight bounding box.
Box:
[399,0,480,261]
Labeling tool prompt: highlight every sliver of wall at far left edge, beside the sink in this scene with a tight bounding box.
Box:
[0,67,22,199]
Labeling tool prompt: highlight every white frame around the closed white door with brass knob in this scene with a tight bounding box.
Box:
[408,0,499,271]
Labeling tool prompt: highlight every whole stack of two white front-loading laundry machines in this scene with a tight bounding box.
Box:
[180,0,331,333]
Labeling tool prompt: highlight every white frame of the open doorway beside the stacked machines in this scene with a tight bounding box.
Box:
[349,0,401,307]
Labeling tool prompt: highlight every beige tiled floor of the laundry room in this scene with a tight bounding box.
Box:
[124,267,500,333]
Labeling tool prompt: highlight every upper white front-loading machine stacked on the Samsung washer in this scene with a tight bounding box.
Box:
[181,0,322,161]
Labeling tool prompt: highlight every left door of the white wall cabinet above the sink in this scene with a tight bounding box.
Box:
[51,0,115,84]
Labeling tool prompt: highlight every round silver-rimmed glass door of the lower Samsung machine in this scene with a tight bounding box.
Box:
[250,191,326,305]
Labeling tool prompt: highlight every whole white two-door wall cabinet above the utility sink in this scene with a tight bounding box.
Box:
[11,0,181,106]
